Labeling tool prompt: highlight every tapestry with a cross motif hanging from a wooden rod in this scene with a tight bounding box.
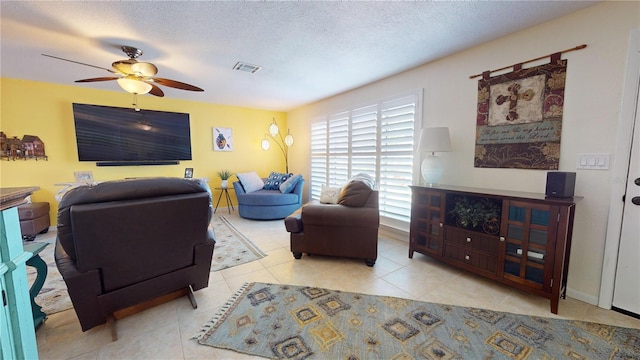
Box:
[474,53,567,170]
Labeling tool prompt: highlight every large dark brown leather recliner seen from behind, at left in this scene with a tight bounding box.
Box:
[55,178,215,340]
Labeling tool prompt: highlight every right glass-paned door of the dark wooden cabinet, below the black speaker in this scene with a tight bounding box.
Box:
[502,201,551,286]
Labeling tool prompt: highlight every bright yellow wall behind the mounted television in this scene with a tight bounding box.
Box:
[0,78,286,225]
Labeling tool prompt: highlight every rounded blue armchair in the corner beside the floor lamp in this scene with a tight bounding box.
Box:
[233,179,304,220]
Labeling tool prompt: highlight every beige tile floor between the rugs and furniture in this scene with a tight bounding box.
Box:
[36,209,640,359]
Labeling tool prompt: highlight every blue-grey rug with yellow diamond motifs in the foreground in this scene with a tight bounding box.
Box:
[194,283,640,359]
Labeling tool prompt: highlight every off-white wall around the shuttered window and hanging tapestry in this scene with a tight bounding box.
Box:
[287,2,640,304]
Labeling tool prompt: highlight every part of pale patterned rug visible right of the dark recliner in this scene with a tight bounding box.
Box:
[211,216,266,271]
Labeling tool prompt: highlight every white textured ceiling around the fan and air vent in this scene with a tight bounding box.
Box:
[0,1,596,111]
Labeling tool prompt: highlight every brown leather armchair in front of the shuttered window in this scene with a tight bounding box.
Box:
[285,187,380,266]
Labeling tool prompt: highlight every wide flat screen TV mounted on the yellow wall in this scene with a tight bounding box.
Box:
[73,103,191,166]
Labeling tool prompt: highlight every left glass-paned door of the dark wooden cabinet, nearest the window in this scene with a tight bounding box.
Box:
[412,191,444,255]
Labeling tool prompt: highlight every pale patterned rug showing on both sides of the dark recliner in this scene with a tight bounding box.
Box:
[27,216,266,315]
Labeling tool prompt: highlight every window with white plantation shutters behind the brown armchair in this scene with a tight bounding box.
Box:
[311,92,422,226]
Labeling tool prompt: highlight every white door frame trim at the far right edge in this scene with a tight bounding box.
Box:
[598,28,640,309]
